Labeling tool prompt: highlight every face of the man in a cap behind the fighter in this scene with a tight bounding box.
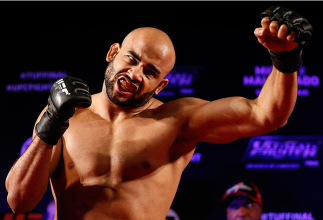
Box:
[226,196,262,220]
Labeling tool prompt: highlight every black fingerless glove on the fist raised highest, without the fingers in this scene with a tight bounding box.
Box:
[260,6,313,73]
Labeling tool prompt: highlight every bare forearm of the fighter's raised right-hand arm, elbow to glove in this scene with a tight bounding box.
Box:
[255,66,297,127]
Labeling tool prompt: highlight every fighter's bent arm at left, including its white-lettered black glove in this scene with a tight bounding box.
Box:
[6,77,91,213]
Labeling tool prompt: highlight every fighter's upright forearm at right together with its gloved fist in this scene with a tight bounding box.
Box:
[255,5,313,127]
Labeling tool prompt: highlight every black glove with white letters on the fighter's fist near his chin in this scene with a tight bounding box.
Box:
[35,76,92,145]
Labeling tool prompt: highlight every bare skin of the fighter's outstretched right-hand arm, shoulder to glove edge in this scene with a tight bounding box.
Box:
[184,65,297,143]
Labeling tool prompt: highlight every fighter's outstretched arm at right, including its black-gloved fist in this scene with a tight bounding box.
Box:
[182,6,312,143]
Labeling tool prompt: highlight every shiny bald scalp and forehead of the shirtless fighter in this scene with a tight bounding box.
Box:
[121,27,176,74]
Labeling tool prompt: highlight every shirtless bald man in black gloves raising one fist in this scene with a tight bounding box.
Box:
[6,5,314,220]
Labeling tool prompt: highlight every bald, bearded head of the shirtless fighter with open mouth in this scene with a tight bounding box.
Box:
[105,29,175,108]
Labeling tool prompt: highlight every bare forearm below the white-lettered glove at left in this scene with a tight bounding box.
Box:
[6,136,53,213]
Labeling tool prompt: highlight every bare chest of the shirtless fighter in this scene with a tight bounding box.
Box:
[63,116,177,187]
